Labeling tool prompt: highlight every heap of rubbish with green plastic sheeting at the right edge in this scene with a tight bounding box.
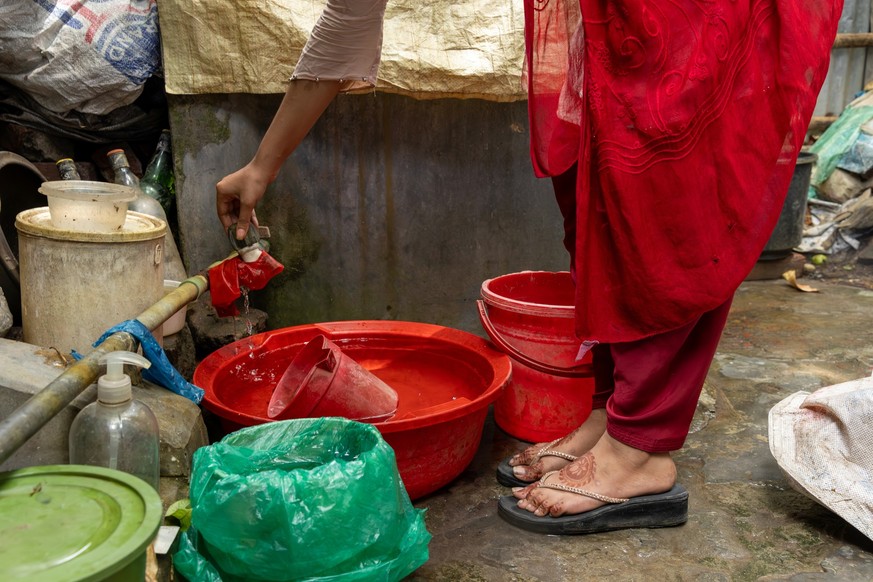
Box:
[796,91,873,255]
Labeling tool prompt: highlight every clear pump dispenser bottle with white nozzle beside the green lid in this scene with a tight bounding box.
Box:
[70,352,160,490]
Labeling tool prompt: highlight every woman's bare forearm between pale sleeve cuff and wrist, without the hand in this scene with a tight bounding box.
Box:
[251,79,340,182]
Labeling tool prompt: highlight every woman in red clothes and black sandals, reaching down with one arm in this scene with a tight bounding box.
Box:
[216,0,842,533]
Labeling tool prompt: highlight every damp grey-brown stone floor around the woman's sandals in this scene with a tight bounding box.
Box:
[408,279,873,582]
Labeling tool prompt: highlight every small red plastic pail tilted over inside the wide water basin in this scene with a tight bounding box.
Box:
[267,335,397,422]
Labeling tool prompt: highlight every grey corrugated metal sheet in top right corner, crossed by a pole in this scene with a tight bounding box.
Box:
[814,0,873,116]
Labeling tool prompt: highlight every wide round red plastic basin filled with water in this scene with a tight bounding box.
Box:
[193,321,512,499]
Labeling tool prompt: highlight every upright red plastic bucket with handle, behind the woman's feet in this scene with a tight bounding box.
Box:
[479,271,594,442]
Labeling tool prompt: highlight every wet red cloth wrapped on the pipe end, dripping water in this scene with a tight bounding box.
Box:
[209,252,285,317]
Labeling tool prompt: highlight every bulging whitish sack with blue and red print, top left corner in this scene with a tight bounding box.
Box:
[0,0,161,115]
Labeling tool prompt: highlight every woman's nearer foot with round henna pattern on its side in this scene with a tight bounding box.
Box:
[513,434,676,517]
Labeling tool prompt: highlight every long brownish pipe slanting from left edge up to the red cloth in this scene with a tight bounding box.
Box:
[0,274,209,464]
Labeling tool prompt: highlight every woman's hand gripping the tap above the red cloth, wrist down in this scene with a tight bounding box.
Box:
[215,164,270,240]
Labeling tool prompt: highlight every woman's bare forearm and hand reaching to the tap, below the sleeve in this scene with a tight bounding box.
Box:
[215,79,341,240]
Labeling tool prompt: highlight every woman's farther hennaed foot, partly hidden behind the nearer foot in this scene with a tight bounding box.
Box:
[509,408,606,483]
